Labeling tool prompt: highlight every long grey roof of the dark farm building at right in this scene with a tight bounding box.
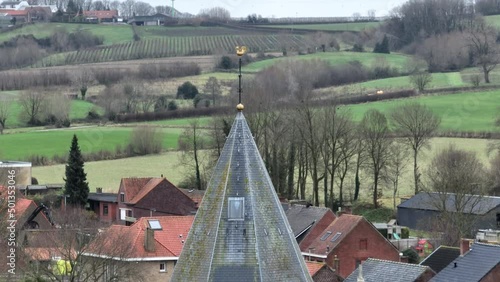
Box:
[398,192,500,215]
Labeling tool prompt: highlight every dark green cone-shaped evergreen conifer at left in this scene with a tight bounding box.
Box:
[64,135,89,207]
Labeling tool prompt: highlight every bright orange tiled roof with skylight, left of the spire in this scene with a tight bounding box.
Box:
[86,216,194,260]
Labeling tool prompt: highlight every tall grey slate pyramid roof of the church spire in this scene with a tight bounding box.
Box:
[172,112,312,282]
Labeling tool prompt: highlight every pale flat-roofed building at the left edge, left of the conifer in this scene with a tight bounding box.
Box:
[0,161,31,187]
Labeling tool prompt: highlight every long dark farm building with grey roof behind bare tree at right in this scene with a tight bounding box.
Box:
[397,192,500,230]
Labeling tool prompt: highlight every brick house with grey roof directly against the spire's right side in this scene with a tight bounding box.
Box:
[285,204,336,249]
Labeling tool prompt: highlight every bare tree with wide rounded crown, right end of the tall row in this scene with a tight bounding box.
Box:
[391,103,441,194]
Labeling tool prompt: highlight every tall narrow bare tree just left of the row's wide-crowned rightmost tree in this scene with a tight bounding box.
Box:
[360,109,392,208]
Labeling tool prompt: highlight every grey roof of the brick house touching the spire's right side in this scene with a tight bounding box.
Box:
[285,205,331,237]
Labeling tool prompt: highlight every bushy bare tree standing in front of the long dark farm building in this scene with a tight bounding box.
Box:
[427,145,487,246]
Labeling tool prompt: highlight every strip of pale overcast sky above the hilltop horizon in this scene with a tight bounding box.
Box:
[149,0,407,18]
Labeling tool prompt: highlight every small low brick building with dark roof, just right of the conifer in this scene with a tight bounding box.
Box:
[88,188,118,222]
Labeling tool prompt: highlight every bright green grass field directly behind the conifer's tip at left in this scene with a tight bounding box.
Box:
[0,126,182,161]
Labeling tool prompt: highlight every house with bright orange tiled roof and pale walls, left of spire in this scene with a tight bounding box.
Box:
[82,216,196,281]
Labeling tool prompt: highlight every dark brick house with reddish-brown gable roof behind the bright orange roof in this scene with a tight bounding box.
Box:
[116,177,197,225]
